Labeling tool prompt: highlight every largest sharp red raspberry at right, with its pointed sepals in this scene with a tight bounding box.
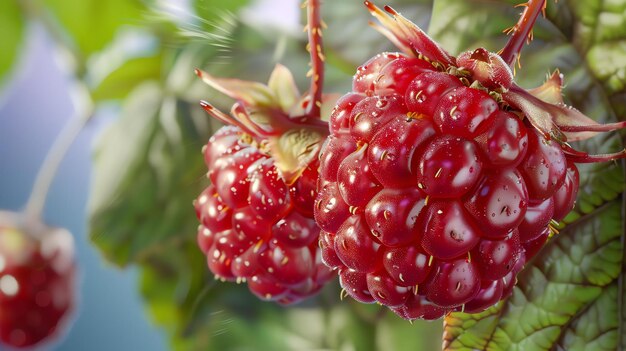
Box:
[314,2,626,319]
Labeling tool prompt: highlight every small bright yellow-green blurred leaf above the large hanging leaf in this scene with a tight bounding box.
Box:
[91,55,163,101]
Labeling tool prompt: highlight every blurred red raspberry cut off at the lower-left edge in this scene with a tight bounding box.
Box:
[0,211,76,348]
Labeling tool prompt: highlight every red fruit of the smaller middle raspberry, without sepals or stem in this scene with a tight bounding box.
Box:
[195,126,332,304]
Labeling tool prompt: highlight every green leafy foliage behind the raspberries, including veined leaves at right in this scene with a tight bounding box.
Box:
[0,0,626,350]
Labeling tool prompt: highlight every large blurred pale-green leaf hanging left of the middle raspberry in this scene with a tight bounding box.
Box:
[89,83,211,266]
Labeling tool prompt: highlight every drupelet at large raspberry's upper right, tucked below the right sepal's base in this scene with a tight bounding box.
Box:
[476,111,528,168]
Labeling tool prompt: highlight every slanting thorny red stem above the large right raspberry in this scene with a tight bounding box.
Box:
[500,0,546,67]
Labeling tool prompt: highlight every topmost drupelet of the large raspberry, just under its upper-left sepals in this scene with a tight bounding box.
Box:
[374,57,434,96]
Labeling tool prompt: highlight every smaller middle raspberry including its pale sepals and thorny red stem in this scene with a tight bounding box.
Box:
[195,0,336,304]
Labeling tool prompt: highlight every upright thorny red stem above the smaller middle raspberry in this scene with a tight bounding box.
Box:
[306,0,325,118]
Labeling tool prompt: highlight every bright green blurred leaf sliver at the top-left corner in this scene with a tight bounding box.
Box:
[0,0,25,87]
